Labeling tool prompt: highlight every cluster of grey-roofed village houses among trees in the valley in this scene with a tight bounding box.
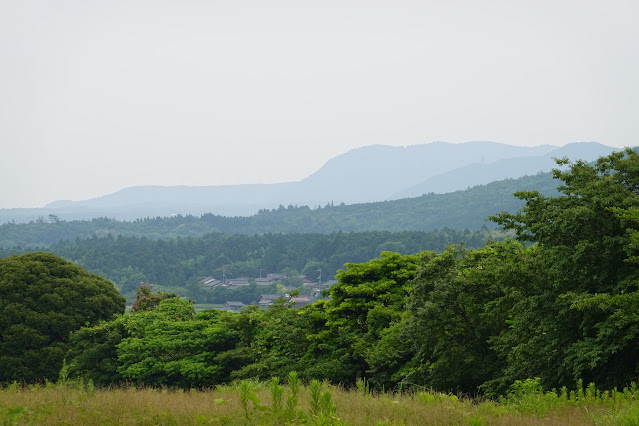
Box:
[200,274,337,312]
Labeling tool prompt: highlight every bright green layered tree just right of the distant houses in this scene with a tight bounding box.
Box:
[301,252,434,385]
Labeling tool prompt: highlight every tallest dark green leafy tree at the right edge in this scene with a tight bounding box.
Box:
[494,149,639,387]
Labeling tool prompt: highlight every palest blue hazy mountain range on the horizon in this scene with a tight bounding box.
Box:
[0,142,618,223]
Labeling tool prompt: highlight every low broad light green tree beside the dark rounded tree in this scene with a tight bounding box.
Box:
[67,297,241,388]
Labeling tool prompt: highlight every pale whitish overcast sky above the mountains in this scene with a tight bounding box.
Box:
[0,0,639,208]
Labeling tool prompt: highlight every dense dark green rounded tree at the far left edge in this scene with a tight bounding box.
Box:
[0,253,125,382]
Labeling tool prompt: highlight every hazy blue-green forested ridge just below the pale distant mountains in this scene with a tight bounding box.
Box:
[0,173,558,248]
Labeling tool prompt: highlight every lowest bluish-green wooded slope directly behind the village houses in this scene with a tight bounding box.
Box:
[0,229,502,303]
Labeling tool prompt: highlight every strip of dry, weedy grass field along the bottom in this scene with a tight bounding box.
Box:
[0,381,639,425]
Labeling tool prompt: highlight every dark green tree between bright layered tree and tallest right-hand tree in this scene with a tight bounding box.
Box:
[402,241,531,394]
